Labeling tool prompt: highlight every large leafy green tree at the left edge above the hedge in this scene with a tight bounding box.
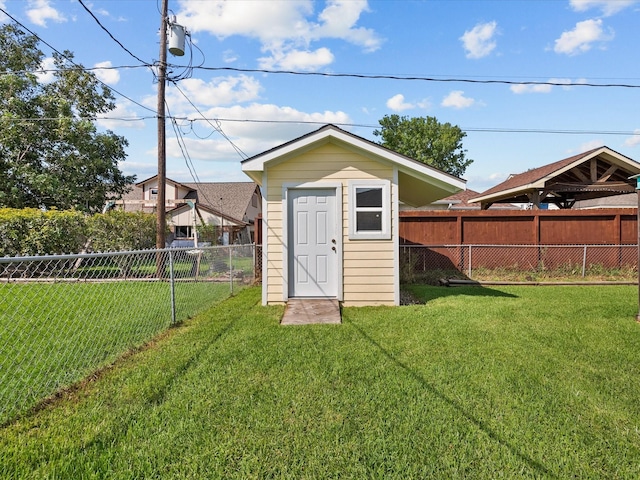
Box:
[0,24,135,212]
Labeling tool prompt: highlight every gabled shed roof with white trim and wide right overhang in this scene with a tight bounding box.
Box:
[242,125,466,206]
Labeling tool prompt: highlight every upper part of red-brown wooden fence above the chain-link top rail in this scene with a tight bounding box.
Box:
[400,208,638,245]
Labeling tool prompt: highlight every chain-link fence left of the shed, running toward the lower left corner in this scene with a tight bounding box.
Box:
[0,245,255,425]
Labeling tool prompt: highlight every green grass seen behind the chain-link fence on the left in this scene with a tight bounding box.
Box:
[0,281,235,424]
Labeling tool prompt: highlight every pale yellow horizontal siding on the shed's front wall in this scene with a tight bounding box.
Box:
[263,144,397,306]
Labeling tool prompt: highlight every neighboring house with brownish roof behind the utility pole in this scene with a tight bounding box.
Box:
[111,176,262,246]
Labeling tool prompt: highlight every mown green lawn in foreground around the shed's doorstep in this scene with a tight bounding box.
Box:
[0,286,640,479]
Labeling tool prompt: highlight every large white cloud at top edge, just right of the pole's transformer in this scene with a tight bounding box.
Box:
[178,0,382,69]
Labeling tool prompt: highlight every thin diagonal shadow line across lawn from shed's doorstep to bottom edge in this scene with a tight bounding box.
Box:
[350,318,558,478]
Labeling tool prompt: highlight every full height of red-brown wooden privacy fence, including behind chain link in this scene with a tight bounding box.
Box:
[400,209,638,277]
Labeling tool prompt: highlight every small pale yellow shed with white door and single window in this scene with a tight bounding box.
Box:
[242,125,465,306]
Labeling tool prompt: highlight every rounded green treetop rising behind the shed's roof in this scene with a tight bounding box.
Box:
[373,115,473,177]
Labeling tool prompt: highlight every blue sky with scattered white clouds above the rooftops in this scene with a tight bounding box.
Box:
[0,0,640,191]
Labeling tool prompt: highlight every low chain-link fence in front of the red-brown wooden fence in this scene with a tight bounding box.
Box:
[400,245,638,284]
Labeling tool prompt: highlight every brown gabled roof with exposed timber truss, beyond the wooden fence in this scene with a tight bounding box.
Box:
[470,147,640,204]
